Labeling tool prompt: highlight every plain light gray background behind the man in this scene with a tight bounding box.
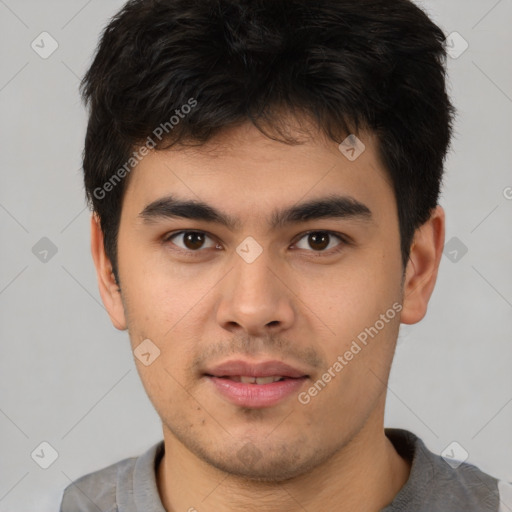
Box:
[0,0,512,512]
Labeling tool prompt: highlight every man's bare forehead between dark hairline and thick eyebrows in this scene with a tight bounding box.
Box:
[123,121,394,227]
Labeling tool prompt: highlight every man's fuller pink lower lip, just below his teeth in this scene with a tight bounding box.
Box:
[207,375,307,409]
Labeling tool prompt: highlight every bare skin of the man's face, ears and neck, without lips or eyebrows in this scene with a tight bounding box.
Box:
[91,118,445,512]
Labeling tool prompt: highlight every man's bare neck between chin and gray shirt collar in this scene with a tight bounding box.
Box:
[157,402,410,512]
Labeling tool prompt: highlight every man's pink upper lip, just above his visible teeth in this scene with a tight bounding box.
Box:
[205,359,308,379]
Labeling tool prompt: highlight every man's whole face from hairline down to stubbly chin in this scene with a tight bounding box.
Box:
[95,125,416,481]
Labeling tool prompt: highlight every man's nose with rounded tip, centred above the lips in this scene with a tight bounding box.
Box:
[217,246,296,336]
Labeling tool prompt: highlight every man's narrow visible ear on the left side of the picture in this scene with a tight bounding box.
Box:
[91,213,126,331]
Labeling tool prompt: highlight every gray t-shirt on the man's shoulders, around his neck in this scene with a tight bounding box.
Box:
[60,428,512,512]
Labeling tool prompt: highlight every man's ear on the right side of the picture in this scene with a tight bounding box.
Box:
[400,206,445,324]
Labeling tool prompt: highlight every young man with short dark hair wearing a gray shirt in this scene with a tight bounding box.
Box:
[61,0,510,512]
